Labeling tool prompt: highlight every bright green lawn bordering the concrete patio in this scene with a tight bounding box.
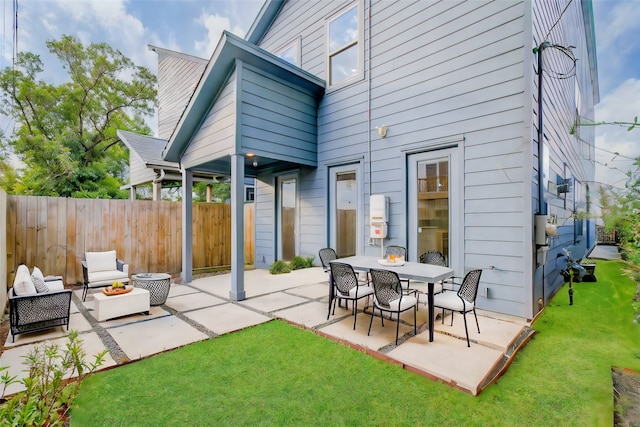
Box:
[71,261,640,426]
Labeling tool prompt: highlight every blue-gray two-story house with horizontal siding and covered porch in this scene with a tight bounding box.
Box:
[141,0,599,318]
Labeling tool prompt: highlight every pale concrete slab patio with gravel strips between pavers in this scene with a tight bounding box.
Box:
[0,267,531,395]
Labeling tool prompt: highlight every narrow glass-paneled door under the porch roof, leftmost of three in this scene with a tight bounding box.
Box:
[278,176,298,261]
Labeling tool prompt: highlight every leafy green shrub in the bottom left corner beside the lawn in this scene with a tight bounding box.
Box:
[0,330,107,426]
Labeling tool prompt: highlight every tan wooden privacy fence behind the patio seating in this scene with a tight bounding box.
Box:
[6,196,254,284]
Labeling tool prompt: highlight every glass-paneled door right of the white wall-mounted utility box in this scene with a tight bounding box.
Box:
[408,149,457,266]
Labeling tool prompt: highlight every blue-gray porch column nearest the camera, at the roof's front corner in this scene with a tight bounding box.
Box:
[229,154,246,301]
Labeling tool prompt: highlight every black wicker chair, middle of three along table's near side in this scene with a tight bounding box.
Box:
[367,269,418,345]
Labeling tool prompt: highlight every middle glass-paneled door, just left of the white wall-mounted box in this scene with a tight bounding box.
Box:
[329,165,361,258]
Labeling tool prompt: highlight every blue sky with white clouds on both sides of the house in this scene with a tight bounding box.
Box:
[0,0,640,186]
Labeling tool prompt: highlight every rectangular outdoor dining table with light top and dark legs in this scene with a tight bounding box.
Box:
[329,256,453,342]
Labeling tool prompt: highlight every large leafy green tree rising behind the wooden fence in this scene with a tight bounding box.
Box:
[0,35,157,198]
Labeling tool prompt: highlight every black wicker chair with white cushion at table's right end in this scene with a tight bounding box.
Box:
[433,270,482,347]
